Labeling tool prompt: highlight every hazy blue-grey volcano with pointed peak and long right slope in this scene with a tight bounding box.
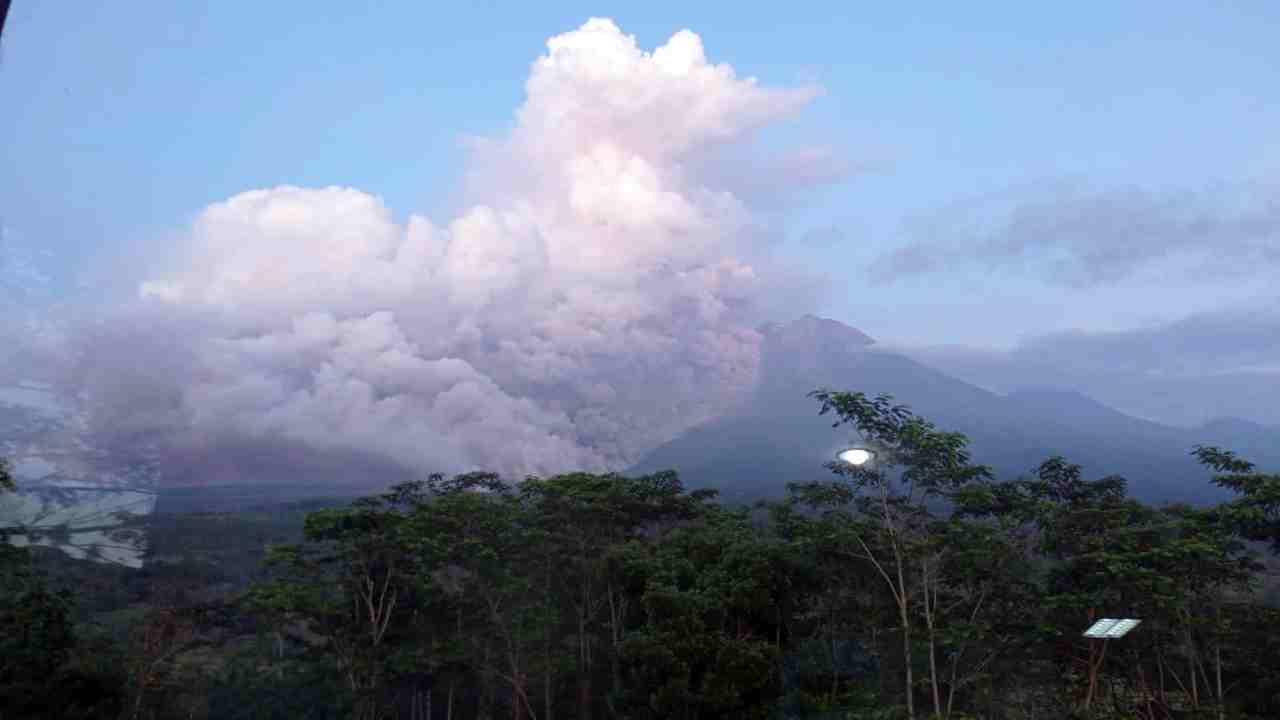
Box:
[632,315,1280,502]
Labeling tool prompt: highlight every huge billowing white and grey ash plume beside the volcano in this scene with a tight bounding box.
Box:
[32,19,815,474]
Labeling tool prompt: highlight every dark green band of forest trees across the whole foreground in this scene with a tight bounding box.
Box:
[0,391,1280,720]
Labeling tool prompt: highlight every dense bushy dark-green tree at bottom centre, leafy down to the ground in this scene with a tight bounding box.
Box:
[611,511,788,720]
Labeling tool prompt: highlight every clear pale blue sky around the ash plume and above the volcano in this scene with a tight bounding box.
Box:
[0,0,1280,346]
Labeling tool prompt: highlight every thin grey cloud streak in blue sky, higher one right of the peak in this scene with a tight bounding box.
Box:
[867,182,1280,290]
